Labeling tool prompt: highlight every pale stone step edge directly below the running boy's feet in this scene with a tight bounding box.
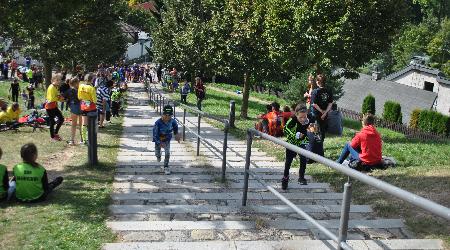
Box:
[114,174,311,183]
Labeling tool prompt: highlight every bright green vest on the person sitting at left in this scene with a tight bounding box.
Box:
[13,163,45,201]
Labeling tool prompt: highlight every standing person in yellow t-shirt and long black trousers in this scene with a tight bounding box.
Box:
[45,74,64,141]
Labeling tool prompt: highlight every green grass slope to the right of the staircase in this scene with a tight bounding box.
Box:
[165,84,450,246]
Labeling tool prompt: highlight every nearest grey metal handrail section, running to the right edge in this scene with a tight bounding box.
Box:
[242,129,450,249]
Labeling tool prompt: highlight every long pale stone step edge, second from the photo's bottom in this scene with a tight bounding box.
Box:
[106,219,404,231]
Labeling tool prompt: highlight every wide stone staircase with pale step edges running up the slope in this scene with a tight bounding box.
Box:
[104,84,443,250]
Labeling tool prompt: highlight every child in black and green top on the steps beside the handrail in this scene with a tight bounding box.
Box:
[281,104,312,190]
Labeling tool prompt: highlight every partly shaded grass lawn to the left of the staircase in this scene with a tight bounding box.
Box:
[0,80,122,249]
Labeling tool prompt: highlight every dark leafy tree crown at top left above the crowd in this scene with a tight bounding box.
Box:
[5,0,125,85]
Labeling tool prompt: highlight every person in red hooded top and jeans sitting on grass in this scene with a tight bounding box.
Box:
[337,113,382,168]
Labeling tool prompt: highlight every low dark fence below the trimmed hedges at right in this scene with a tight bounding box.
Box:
[338,108,450,140]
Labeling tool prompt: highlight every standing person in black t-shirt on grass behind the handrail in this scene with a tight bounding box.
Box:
[311,74,333,140]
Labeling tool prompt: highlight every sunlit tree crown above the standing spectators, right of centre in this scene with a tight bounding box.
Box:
[265,0,407,75]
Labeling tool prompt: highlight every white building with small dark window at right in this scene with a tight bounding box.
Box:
[385,63,450,115]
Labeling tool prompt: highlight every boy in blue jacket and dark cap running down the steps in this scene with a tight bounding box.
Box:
[153,105,180,175]
